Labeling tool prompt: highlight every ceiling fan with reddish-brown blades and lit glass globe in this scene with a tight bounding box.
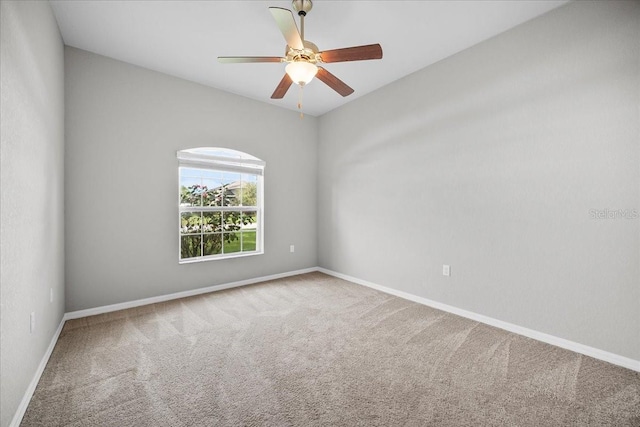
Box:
[218,0,382,108]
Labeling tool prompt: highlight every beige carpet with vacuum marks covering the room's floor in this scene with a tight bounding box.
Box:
[22,273,640,427]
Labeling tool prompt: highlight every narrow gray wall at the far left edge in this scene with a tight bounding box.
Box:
[0,1,64,426]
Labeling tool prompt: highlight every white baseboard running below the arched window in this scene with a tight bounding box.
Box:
[64,267,318,320]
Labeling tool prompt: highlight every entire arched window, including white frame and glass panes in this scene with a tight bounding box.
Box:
[178,148,265,263]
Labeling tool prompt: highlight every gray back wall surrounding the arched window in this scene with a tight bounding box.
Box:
[65,47,317,311]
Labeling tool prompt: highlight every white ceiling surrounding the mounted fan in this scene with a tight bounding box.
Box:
[51,0,567,116]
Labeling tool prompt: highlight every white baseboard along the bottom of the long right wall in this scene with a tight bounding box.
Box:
[317,267,640,372]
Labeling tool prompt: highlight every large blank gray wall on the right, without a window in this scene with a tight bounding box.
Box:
[318,2,640,360]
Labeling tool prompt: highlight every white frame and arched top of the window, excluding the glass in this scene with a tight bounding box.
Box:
[177,147,266,264]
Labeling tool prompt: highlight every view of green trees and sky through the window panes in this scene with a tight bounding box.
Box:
[180,167,258,259]
